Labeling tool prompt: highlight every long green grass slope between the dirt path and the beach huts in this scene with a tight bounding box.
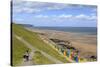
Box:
[12,24,68,63]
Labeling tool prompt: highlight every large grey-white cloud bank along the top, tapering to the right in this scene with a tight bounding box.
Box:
[13,0,76,13]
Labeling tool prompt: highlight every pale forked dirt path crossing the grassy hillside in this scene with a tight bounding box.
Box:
[15,35,63,66]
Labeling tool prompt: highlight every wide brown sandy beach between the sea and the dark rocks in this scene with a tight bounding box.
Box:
[27,28,97,57]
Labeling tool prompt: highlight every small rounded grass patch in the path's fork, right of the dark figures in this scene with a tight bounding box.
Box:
[33,51,54,64]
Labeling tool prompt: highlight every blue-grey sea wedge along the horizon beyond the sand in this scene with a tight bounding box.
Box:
[30,27,97,35]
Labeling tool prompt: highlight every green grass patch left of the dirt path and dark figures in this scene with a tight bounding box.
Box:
[12,36,28,66]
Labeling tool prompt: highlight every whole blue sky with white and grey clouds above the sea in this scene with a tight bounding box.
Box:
[12,0,97,27]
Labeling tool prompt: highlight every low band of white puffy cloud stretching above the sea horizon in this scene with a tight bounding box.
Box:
[34,14,97,20]
